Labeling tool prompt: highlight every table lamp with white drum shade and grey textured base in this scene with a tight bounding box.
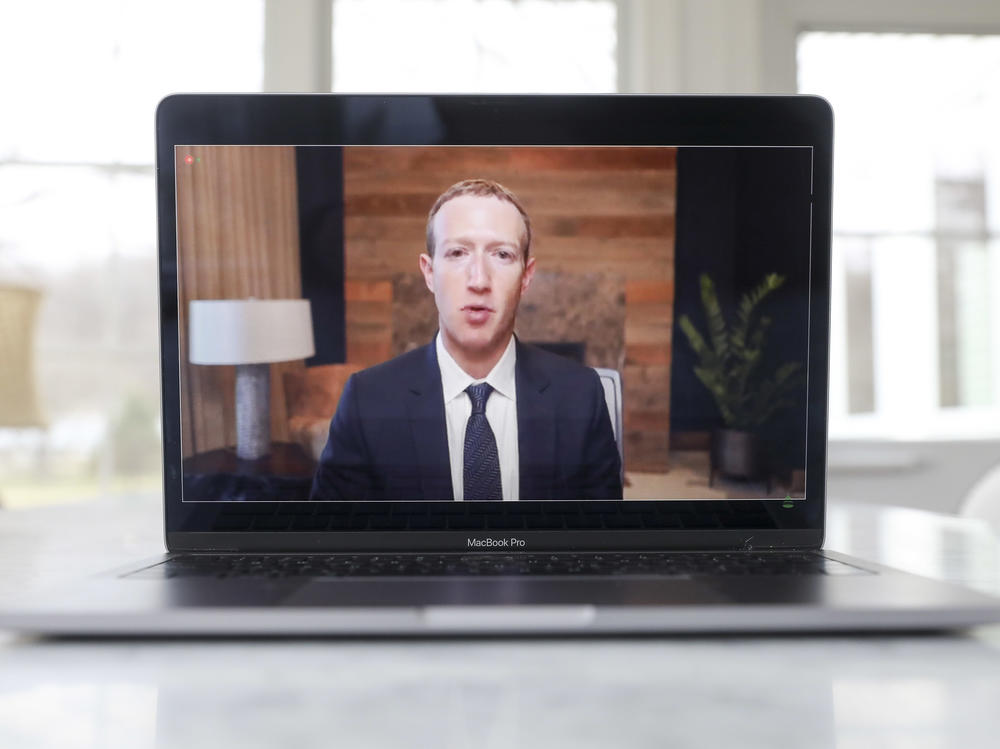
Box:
[188,298,316,460]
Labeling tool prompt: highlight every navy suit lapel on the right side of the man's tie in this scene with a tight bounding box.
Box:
[514,341,556,500]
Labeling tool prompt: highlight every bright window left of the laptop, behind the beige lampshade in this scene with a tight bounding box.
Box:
[0,0,264,507]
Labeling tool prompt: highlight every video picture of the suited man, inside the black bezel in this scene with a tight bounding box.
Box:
[176,145,812,502]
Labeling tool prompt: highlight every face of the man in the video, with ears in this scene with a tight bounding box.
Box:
[420,195,535,366]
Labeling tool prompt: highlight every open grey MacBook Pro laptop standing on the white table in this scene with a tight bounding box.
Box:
[0,94,1000,635]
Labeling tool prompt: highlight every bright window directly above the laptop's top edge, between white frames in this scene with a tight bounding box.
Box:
[333,0,617,93]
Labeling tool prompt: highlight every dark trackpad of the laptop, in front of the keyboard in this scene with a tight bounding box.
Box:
[282,577,726,606]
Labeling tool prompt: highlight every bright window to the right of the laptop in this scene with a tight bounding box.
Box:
[798,32,1000,439]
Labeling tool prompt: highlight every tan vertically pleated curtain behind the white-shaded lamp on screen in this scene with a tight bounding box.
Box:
[176,146,304,457]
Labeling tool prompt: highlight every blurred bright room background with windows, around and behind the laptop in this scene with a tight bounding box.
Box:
[0,0,1000,512]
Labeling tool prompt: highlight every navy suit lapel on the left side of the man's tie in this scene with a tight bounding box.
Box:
[407,342,455,499]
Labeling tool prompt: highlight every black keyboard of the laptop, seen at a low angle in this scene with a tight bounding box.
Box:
[132,552,871,579]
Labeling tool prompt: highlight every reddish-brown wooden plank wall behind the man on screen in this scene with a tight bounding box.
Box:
[344,147,677,472]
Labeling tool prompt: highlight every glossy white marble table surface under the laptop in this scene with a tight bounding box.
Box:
[0,490,1000,749]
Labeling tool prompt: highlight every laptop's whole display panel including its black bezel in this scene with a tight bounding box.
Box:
[157,94,832,550]
